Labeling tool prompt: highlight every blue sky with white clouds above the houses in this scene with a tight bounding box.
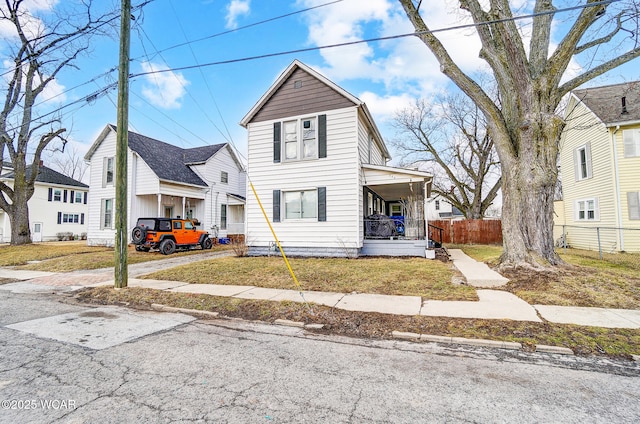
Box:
[0,0,640,171]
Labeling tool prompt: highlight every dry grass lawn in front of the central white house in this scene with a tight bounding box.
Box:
[145,257,477,300]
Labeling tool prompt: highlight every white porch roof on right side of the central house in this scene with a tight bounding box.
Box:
[362,164,433,200]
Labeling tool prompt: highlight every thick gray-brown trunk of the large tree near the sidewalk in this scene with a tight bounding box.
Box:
[496,85,564,268]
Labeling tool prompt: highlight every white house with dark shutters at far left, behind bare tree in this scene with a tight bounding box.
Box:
[0,165,89,243]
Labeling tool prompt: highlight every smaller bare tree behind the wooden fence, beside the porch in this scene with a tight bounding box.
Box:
[393,94,501,219]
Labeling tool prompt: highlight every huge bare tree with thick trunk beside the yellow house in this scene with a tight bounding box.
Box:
[399,0,640,268]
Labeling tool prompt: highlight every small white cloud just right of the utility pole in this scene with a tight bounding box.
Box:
[142,62,189,109]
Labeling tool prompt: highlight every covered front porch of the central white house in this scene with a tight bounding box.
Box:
[360,165,433,257]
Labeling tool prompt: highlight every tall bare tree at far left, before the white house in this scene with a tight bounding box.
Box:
[0,0,118,244]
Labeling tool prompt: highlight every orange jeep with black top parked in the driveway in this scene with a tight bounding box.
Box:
[131,218,213,255]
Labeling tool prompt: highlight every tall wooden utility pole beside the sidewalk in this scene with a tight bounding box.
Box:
[114,0,131,289]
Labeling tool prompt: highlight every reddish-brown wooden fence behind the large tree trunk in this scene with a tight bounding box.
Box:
[429,219,502,244]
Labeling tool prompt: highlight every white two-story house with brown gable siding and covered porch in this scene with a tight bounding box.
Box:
[241,60,432,257]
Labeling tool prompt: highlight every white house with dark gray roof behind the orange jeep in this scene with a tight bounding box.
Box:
[85,125,246,246]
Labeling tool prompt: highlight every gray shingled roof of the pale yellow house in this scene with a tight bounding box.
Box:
[572,81,640,124]
